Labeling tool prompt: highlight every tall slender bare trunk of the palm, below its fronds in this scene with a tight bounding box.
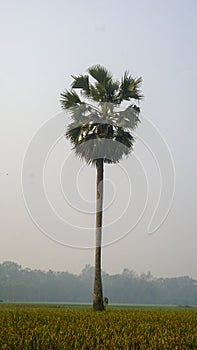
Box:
[93,159,105,311]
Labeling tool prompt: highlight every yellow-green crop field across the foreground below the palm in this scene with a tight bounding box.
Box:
[0,304,197,350]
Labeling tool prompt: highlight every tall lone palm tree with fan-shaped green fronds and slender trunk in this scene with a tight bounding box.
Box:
[60,65,142,311]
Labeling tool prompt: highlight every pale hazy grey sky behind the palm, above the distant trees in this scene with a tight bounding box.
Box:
[0,0,197,278]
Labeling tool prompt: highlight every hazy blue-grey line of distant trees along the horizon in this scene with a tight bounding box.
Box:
[0,261,197,305]
